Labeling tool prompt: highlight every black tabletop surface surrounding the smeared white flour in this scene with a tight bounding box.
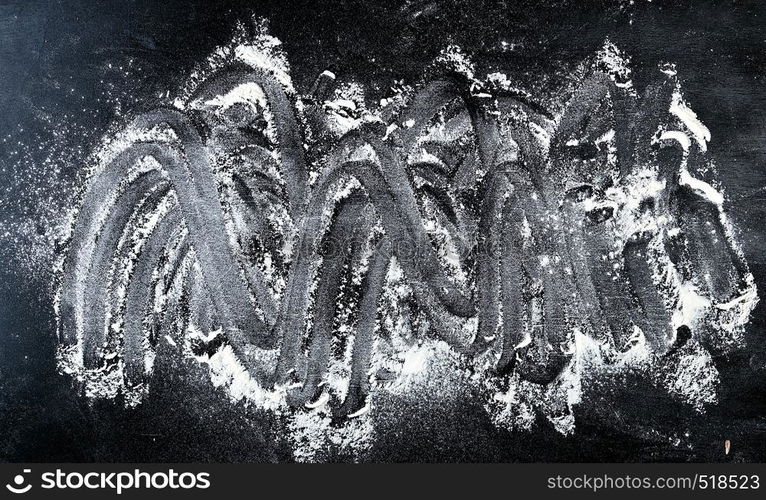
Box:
[0,0,766,461]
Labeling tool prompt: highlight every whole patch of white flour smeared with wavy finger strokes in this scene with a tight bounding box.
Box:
[56,20,758,461]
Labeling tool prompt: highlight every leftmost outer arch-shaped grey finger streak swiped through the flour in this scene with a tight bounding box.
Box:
[62,131,276,374]
